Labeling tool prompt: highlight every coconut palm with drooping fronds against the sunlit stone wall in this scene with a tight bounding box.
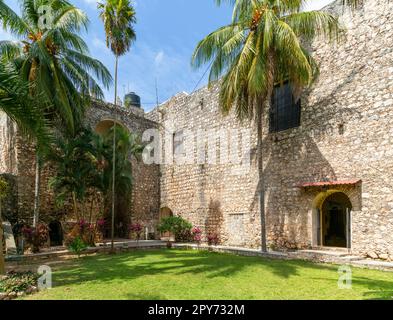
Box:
[192,0,340,252]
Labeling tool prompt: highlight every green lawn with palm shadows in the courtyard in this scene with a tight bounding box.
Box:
[28,250,393,300]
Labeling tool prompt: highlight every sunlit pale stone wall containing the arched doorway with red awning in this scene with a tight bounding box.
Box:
[148,0,393,259]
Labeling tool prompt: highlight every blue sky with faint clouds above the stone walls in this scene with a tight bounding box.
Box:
[0,0,332,110]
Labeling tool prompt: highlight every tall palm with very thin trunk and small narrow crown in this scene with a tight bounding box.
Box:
[98,0,136,253]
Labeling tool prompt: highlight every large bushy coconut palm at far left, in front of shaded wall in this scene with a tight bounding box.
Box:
[0,0,112,228]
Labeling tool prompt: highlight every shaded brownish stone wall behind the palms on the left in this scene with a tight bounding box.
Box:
[0,102,160,232]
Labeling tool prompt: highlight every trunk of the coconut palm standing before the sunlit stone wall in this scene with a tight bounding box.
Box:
[257,103,267,252]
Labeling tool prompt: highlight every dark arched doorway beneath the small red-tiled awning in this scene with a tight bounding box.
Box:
[317,192,352,248]
